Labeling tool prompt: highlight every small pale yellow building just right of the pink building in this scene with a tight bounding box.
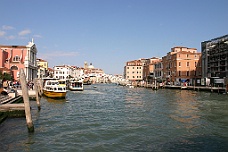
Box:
[36,59,48,78]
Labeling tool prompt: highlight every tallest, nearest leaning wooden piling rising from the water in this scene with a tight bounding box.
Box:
[20,69,34,132]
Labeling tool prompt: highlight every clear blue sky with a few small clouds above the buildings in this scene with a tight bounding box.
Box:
[0,0,228,74]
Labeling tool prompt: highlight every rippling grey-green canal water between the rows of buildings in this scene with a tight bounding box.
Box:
[0,84,228,152]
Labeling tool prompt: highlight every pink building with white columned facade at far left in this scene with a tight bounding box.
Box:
[0,39,37,81]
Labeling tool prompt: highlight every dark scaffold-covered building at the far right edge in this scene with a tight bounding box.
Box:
[201,35,228,79]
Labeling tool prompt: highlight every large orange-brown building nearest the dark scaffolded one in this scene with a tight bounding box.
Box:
[162,47,202,85]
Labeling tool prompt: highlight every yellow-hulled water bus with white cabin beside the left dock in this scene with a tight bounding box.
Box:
[43,79,67,98]
